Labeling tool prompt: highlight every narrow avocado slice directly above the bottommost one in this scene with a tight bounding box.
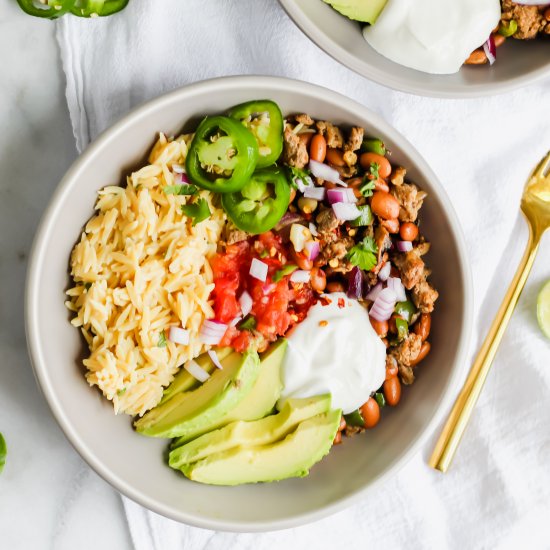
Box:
[168,396,330,470]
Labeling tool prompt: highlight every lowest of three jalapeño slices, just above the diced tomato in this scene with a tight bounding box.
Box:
[222,166,290,235]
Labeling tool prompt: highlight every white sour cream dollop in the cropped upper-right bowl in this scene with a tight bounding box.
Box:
[363,0,500,74]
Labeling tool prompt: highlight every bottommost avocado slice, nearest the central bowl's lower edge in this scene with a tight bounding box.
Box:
[181,409,342,485]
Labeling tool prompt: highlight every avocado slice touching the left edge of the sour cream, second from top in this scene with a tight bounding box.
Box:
[171,338,288,448]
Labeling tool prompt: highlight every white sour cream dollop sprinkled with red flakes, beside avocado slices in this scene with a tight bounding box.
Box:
[281,292,386,413]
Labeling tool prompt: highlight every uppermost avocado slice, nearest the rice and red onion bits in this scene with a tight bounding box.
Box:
[135,352,260,438]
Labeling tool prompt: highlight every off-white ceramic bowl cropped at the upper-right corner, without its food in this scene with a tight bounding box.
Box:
[279,0,550,98]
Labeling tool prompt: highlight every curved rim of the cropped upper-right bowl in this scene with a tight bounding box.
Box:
[279,0,550,99]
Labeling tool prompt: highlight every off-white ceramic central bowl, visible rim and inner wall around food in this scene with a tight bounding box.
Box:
[26,77,472,531]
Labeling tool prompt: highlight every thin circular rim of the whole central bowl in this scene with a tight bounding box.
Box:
[25,76,473,532]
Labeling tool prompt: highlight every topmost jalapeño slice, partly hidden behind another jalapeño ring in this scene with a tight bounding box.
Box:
[229,99,284,168]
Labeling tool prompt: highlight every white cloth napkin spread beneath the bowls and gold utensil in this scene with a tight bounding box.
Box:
[57,0,550,550]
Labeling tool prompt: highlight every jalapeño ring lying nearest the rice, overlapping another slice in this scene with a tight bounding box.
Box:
[185,116,258,193]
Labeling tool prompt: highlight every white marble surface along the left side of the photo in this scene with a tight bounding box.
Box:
[0,0,132,550]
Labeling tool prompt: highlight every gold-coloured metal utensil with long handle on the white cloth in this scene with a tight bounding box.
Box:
[430,152,550,472]
